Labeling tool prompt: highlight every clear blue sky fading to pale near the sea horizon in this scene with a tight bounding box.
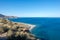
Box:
[0,0,60,17]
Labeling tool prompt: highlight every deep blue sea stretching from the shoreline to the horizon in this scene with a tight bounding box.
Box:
[9,18,60,40]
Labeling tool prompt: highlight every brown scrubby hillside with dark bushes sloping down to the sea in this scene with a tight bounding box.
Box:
[0,18,39,40]
